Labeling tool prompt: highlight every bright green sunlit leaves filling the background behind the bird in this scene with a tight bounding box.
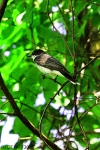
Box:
[0,0,100,150]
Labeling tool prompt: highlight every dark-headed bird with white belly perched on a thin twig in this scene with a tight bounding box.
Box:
[29,49,79,84]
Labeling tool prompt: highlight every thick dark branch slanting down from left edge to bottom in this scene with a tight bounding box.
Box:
[0,74,61,150]
